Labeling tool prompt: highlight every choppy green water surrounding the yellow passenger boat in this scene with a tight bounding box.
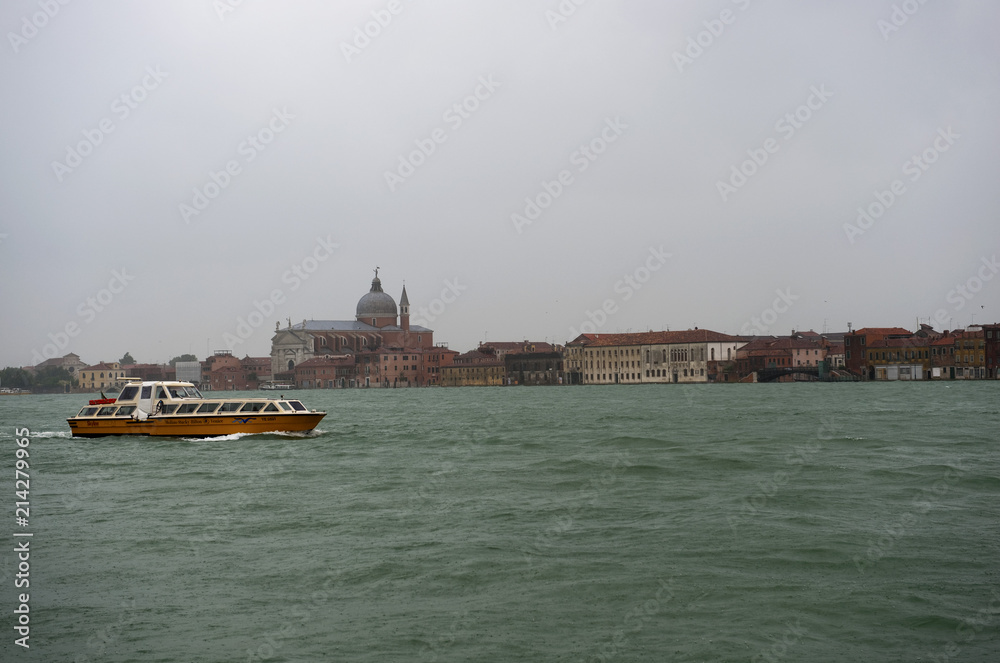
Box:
[0,382,1000,662]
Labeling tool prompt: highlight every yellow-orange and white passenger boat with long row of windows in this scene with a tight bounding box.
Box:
[66,381,326,437]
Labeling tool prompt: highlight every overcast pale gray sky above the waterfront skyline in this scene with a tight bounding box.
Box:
[0,0,1000,365]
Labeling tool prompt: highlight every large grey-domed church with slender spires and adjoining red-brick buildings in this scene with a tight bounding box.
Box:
[271,270,457,389]
